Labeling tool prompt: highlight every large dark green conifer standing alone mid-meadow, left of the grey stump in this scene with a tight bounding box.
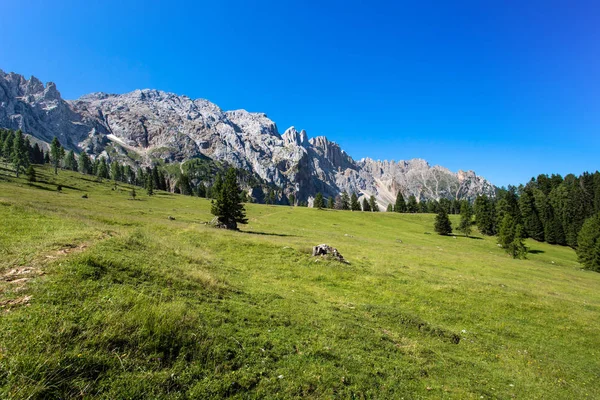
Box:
[211,168,248,229]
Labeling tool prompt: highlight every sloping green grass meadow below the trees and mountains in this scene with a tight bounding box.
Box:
[0,167,600,399]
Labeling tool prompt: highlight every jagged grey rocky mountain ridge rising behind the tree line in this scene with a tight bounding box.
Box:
[0,70,495,208]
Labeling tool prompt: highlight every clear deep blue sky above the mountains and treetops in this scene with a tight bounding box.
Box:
[0,0,600,185]
